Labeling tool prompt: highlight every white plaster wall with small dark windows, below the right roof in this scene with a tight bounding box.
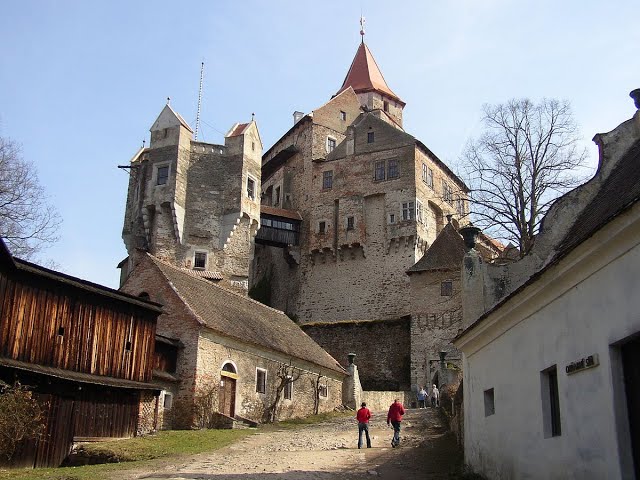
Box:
[456,210,640,479]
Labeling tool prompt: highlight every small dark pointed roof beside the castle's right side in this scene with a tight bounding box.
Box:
[407,223,465,275]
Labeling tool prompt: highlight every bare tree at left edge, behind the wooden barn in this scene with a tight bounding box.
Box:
[0,137,61,259]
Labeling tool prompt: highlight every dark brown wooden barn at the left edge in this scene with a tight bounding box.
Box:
[0,239,162,467]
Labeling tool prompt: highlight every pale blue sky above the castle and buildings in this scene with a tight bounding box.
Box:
[0,0,640,288]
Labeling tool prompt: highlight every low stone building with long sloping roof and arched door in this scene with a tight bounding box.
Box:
[121,251,346,428]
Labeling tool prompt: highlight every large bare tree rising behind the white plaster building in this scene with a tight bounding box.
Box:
[462,99,587,255]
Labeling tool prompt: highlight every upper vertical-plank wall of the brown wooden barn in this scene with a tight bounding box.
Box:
[0,272,155,382]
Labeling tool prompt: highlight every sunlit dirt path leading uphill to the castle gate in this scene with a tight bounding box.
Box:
[119,409,462,480]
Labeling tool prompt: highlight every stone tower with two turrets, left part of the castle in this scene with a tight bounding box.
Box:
[120,103,262,292]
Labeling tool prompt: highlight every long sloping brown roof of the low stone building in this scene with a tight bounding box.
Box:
[144,253,345,374]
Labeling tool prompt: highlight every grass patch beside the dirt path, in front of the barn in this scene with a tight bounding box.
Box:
[0,429,255,480]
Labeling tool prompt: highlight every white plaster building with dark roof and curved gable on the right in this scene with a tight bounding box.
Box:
[454,90,640,479]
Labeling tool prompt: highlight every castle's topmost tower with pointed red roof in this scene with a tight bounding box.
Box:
[336,41,406,128]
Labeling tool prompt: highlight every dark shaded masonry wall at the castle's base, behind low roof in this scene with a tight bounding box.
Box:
[302,317,411,391]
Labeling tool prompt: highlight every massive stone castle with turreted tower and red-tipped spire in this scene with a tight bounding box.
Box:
[121,33,499,390]
